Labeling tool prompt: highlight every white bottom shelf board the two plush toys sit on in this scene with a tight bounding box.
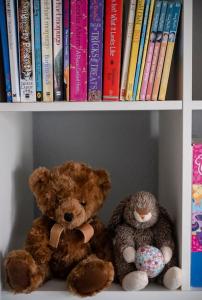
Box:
[2,280,202,300]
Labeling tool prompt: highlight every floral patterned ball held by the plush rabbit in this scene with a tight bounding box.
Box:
[135,246,165,278]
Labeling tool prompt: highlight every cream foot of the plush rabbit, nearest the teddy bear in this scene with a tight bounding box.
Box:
[122,271,149,291]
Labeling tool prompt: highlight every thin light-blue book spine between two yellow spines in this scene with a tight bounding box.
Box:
[133,0,151,100]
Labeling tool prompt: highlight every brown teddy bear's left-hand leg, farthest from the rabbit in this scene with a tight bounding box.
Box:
[5,250,49,293]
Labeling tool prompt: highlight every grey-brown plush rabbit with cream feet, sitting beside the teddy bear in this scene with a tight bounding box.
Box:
[109,192,182,290]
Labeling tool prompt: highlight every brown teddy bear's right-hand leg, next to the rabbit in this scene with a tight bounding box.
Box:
[67,255,114,296]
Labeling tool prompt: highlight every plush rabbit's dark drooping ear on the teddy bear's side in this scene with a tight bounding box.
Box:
[108,196,131,233]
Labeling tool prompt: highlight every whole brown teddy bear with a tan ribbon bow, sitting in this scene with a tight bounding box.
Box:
[5,162,114,296]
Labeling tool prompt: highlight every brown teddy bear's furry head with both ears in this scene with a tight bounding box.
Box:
[29,162,111,229]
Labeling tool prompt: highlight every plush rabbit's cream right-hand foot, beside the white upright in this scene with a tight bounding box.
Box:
[163,267,182,290]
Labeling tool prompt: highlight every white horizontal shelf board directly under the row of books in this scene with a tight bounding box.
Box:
[0,101,182,112]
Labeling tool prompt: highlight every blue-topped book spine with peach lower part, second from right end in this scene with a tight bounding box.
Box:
[152,3,174,100]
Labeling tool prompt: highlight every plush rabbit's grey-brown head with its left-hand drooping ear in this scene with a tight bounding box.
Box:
[109,192,159,229]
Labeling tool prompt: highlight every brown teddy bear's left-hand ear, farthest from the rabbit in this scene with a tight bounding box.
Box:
[29,167,50,194]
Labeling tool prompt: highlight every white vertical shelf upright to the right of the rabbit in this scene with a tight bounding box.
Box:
[182,0,193,290]
